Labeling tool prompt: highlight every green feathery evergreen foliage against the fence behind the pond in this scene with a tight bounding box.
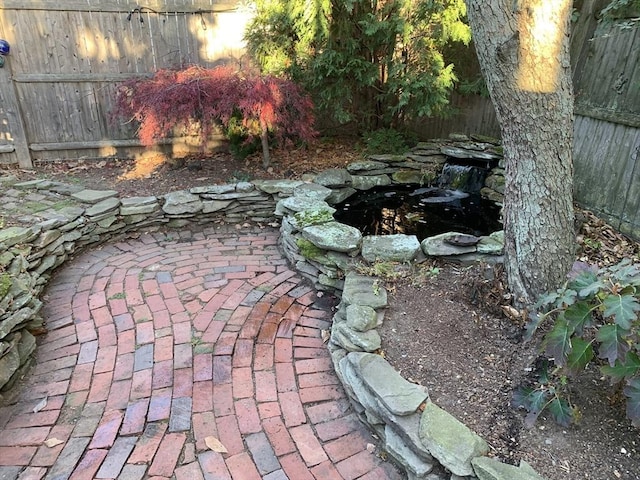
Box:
[245,0,471,131]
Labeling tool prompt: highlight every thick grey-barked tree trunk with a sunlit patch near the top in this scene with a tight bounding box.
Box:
[467,0,575,306]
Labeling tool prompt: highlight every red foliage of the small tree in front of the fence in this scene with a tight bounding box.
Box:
[115,66,316,150]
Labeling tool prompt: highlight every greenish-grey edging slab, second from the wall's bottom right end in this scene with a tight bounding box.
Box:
[420,402,489,476]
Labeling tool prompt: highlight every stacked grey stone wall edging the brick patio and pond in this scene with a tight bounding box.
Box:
[0,137,542,480]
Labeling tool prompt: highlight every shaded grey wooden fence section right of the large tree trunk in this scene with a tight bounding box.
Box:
[571,0,640,239]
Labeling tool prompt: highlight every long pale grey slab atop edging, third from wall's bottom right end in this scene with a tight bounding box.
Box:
[347,352,428,416]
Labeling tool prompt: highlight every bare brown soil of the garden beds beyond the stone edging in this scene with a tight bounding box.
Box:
[0,140,640,480]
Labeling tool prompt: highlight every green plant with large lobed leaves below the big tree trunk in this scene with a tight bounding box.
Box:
[514,259,640,427]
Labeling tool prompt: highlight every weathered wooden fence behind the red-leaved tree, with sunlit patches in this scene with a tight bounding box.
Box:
[0,0,251,167]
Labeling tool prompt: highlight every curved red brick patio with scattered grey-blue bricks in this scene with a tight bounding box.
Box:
[0,229,401,480]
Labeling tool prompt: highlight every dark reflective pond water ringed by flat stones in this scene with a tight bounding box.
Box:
[334,185,502,241]
